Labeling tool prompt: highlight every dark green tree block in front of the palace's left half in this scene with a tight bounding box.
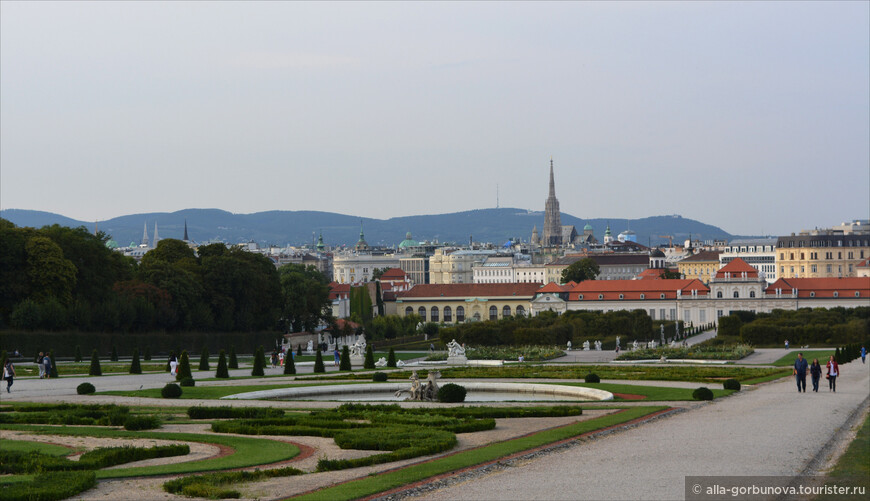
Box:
[440,310,656,346]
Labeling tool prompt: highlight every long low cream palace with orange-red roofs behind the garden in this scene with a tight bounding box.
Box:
[396,258,870,325]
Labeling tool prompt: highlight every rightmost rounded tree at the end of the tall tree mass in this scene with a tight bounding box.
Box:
[278,263,329,332]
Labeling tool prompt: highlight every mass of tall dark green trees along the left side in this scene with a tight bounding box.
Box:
[0,220,329,332]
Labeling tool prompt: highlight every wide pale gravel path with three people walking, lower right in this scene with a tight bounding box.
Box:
[410,362,870,500]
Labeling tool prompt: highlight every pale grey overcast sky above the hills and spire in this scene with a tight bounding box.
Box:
[0,1,870,234]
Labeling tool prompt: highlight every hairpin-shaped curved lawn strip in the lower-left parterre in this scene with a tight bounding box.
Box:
[3,425,299,479]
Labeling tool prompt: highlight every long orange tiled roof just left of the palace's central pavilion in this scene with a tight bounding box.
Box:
[568,279,710,301]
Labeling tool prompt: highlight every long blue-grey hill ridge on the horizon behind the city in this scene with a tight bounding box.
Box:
[0,208,735,245]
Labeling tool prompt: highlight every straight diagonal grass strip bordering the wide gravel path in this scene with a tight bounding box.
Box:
[293,406,667,501]
